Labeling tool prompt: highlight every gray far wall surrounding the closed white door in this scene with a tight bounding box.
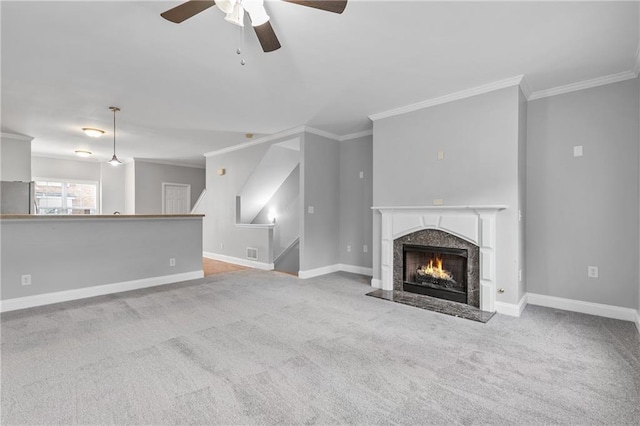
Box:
[135,160,205,214]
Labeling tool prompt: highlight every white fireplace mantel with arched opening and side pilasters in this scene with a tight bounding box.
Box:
[373,205,507,312]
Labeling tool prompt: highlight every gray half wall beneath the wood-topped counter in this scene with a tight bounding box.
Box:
[0,217,202,300]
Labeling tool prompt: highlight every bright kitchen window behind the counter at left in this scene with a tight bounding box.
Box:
[35,179,99,214]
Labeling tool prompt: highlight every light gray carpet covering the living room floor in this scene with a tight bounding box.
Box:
[1,270,640,425]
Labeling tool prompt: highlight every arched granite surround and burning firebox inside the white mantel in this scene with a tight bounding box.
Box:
[393,229,480,308]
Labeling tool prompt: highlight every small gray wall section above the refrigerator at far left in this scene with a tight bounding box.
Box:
[0,133,31,182]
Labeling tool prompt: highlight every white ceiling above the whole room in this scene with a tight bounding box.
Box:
[1,0,640,164]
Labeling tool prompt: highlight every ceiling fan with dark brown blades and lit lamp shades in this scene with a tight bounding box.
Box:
[160,0,347,52]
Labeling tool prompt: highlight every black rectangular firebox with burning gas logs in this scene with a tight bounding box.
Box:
[402,244,469,303]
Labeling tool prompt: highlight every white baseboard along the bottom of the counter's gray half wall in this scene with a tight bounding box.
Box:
[0,270,204,312]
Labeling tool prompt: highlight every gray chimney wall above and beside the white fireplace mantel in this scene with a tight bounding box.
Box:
[373,87,521,304]
